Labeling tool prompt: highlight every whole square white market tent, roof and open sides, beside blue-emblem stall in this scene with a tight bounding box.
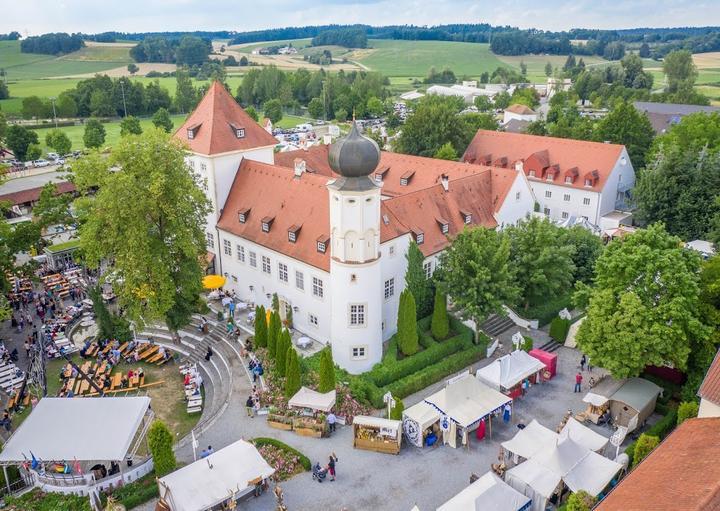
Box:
[425,373,512,447]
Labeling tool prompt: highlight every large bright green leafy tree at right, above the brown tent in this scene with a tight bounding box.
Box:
[575,224,708,378]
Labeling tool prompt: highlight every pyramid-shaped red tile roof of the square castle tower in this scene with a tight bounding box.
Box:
[175,82,277,155]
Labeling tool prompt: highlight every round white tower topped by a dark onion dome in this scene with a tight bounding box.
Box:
[327,122,383,374]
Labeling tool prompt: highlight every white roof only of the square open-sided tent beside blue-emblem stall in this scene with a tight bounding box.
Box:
[425,374,512,428]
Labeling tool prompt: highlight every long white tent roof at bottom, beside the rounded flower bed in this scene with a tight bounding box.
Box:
[158,440,275,511]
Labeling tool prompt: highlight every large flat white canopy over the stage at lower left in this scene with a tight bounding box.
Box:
[0,397,152,465]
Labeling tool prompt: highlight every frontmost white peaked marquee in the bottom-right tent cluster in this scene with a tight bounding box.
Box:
[505,438,622,511]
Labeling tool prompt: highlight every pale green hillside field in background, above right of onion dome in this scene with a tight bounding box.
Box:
[348,39,510,78]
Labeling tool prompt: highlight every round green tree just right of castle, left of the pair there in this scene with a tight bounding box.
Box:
[436,227,519,326]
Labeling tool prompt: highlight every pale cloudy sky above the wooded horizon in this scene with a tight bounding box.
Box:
[0,0,720,35]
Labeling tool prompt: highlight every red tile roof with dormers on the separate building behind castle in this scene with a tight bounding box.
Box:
[462,130,629,192]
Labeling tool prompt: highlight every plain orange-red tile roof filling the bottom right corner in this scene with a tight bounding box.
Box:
[595,417,720,511]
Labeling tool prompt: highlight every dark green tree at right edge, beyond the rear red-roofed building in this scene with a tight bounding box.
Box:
[633,143,720,241]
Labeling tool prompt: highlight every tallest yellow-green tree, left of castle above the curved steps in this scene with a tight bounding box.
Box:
[73,127,210,328]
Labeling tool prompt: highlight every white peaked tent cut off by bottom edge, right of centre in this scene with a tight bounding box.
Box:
[437,472,531,511]
